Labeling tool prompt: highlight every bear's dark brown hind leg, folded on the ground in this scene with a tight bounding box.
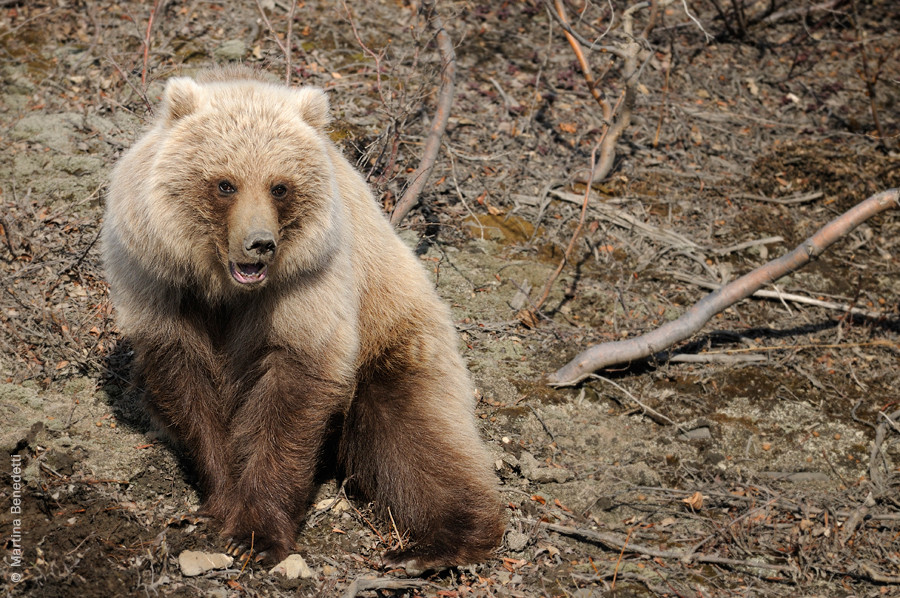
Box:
[341,364,503,574]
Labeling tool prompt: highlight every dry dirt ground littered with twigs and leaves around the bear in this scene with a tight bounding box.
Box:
[0,0,900,598]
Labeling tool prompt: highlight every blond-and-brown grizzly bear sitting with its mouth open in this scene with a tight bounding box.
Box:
[102,70,504,572]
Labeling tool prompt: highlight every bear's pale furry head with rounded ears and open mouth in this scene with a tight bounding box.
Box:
[148,77,341,295]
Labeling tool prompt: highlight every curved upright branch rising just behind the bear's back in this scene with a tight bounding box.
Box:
[391,0,456,226]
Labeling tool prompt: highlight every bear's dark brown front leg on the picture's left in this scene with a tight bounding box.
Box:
[134,333,232,519]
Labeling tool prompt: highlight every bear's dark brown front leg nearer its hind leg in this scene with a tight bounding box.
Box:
[222,350,352,562]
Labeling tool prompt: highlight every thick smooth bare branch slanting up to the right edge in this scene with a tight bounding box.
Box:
[548,189,900,386]
